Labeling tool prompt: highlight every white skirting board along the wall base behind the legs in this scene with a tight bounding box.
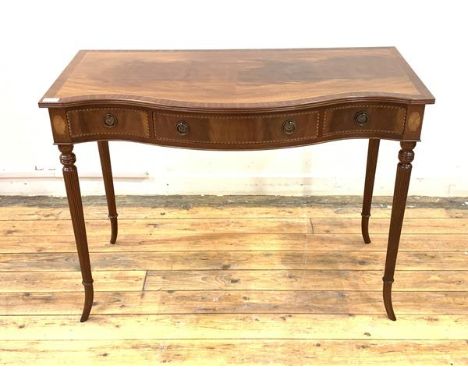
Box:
[0,173,468,197]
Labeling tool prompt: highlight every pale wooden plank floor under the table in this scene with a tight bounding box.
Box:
[0,197,468,365]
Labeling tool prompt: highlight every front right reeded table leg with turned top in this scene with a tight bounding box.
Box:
[383,142,416,321]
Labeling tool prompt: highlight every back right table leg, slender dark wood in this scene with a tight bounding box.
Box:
[361,139,380,244]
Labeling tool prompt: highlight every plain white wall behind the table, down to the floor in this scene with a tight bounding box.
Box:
[0,0,468,196]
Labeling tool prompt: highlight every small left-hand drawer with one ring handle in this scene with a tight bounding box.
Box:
[67,108,150,139]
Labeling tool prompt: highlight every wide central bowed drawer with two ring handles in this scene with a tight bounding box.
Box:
[153,111,319,148]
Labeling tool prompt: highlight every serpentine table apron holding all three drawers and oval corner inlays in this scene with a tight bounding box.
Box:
[49,102,424,150]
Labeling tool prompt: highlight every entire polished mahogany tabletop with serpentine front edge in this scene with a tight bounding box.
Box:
[39,47,434,110]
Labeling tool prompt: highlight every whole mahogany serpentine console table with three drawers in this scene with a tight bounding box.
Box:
[39,47,435,321]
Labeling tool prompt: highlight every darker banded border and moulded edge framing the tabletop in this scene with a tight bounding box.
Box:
[38,47,435,112]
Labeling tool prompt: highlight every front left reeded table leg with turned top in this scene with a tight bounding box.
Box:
[58,145,94,322]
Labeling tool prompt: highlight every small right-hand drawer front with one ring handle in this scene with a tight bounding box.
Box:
[322,104,406,136]
